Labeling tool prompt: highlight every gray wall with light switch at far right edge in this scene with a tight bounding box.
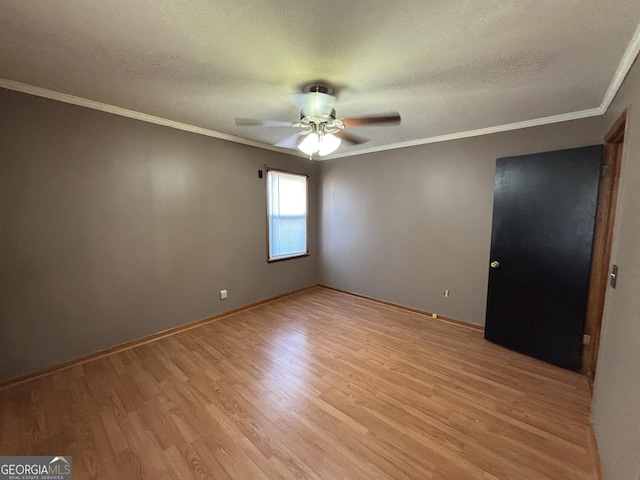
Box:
[592,55,640,480]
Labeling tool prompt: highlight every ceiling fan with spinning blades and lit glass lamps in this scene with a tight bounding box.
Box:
[236,83,400,158]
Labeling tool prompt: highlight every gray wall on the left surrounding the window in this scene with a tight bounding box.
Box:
[0,89,318,381]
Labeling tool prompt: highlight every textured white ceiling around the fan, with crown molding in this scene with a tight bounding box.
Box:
[0,0,640,158]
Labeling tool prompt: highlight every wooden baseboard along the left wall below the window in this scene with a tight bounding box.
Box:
[0,284,318,390]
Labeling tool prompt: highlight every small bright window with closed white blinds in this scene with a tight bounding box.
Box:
[267,170,308,261]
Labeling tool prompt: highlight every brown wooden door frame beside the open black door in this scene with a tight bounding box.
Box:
[580,111,627,386]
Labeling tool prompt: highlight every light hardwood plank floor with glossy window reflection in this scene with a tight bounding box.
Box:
[0,287,598,480]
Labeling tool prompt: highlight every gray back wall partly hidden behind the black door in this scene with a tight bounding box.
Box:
[318,118,603,324]
